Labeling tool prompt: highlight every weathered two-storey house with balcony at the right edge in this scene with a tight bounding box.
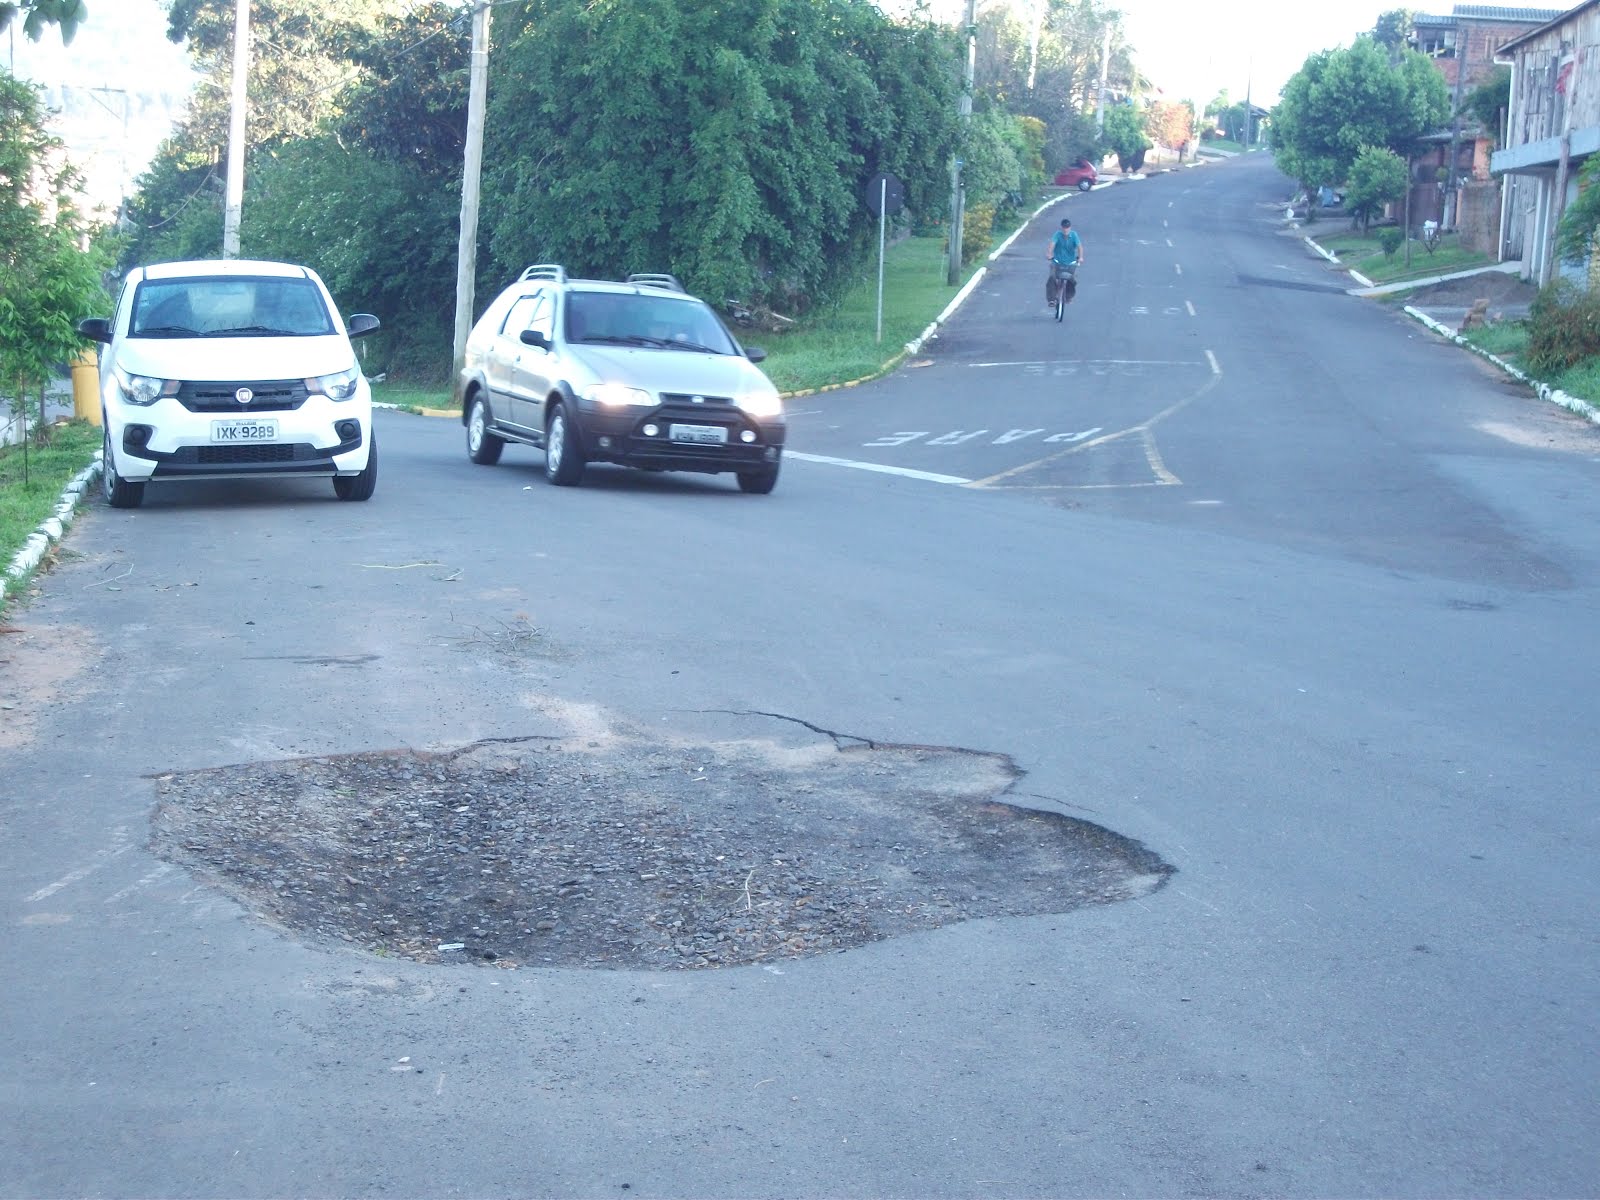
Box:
[1490,0,1600,286]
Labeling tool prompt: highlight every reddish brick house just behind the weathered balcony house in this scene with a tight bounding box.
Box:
[1410,5,1562,249]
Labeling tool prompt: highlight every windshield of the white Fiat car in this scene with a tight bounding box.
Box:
[128,275,333,338]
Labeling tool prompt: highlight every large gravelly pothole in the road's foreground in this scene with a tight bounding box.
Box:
[152,736,1171,970]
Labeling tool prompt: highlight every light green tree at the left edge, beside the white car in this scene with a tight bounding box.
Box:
[0,72,106,460]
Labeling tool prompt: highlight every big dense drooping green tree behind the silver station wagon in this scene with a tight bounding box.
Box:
[483,0,960,310]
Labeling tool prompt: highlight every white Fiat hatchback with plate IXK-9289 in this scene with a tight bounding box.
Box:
[78,259,378,509]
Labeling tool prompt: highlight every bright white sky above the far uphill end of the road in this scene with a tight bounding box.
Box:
[1112,0,1401,107]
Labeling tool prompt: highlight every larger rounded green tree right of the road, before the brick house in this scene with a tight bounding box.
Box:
[1272,37,1450,192]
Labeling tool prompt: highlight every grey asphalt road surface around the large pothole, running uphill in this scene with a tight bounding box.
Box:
[0,158,1600,1197]
